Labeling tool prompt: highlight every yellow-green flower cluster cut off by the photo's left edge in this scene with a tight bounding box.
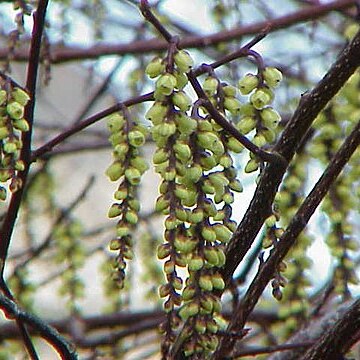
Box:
[0,87,30,201]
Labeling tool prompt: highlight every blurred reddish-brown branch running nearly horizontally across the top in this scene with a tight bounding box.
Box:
[0,0,356,64]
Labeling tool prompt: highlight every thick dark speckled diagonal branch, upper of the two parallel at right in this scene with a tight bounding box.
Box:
[222,28,360,282]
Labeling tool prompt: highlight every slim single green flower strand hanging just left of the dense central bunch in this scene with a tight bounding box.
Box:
[106,111,148,288]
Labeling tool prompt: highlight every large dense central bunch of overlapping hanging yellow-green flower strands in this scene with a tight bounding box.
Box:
[146,50,242,356]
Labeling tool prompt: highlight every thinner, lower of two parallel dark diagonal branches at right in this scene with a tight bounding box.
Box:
[215,121,360,359]
